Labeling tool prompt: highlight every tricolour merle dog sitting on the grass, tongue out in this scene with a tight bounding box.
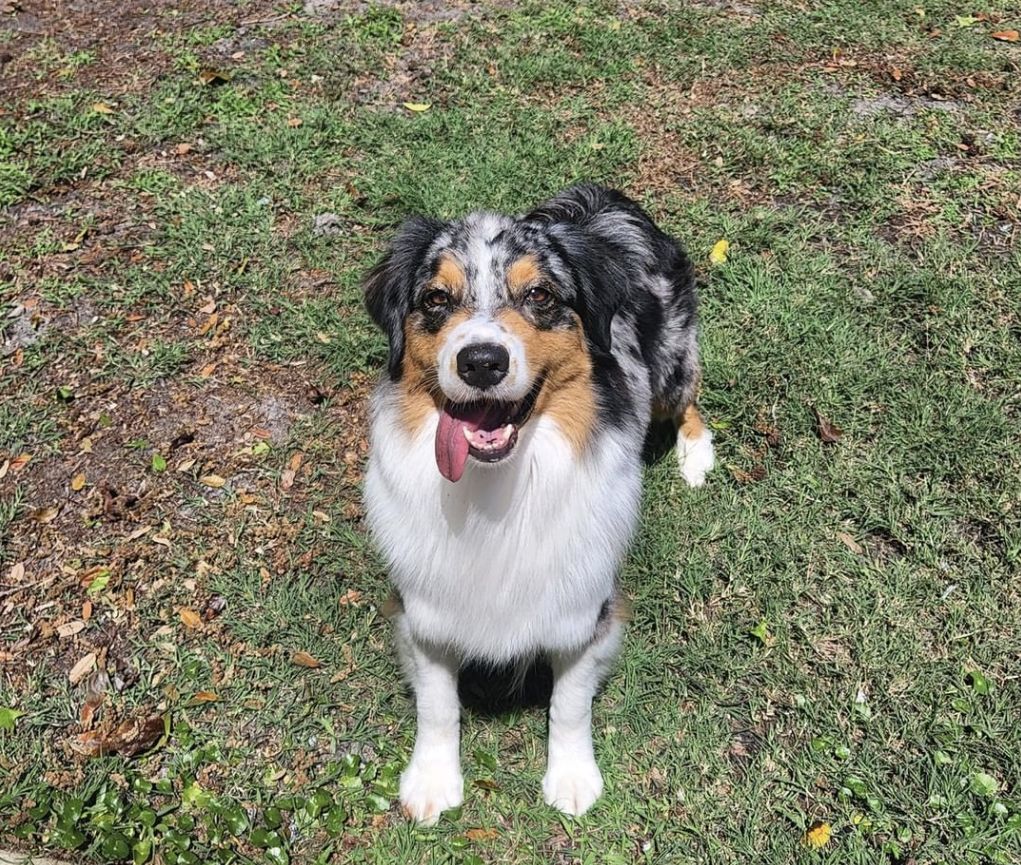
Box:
[364,184,714,825]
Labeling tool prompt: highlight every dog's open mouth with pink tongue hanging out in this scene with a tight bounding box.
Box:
[436,378,542,483]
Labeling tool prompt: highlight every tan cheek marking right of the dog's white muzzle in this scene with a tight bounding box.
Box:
[497,309,596,453]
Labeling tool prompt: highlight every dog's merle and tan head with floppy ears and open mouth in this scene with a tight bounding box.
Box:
[366,208,625,481]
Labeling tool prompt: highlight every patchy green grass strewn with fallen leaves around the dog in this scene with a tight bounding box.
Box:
[0,0,1021,865]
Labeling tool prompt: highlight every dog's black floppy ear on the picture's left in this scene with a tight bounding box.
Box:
[364,217,445,381]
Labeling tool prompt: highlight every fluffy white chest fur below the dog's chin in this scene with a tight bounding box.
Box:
[366,393,640,662]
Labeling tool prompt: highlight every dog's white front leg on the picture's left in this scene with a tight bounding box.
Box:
[397,621,465,826]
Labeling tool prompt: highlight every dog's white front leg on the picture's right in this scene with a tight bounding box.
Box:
[542,617,623,816]
